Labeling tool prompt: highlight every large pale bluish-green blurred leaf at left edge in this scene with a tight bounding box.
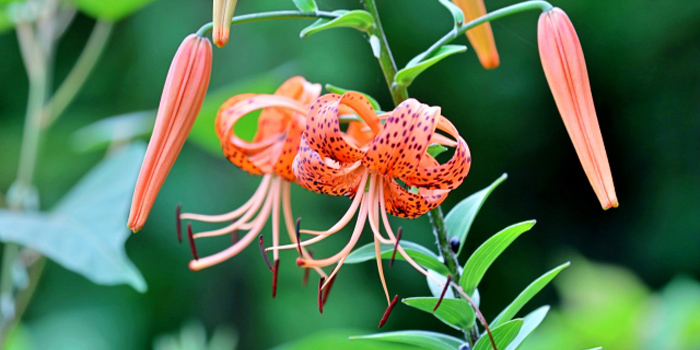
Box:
[0,144,146,292]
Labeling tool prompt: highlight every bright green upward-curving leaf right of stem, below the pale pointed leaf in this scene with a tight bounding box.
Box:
[459,220,535,295]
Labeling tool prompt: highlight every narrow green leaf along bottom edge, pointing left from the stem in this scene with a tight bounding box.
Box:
[350,331,464,350]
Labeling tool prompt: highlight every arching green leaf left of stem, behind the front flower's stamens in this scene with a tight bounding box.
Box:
[345,240,449,274]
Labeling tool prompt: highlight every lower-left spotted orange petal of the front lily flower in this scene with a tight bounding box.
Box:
[293,134,364,196]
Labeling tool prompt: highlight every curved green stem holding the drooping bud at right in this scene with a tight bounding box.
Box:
[414,0,553,62]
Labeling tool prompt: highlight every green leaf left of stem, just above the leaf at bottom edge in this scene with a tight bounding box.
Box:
[401,297,476,331]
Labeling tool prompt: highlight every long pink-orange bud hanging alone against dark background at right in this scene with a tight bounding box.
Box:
[537,8,618,209]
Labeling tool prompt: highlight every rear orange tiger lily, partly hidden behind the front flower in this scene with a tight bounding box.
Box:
[177,77,322,295]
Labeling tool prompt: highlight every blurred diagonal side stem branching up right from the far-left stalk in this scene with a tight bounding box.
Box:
[42,21,114,128]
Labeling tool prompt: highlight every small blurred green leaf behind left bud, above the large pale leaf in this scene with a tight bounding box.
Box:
[70,111,156,152]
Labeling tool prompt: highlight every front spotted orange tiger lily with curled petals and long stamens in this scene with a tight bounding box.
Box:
[280,92,471,326]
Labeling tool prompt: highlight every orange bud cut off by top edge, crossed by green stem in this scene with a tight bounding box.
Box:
[452,0,500,69]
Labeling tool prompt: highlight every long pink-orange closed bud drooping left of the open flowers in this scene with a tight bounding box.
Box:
[127,34,211,232]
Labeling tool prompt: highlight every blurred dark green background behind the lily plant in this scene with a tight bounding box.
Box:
[0,0,700,350]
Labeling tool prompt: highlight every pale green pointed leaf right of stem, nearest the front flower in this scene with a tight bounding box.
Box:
[445,174,508,255]
